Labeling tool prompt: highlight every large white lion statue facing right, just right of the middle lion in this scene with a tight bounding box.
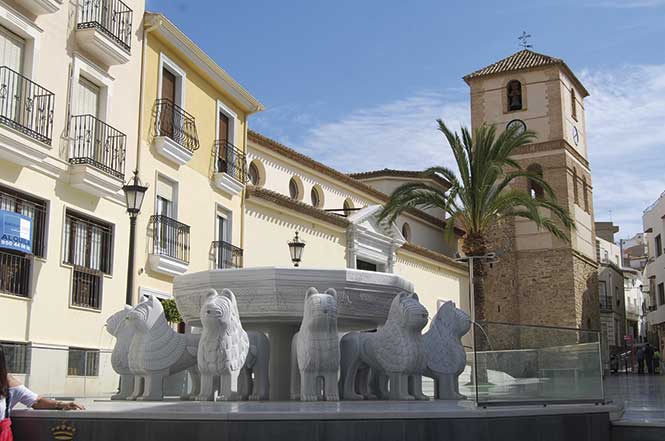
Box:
[340,292,427,400]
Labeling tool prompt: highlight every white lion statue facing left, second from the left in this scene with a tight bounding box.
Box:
[127,295,198,401]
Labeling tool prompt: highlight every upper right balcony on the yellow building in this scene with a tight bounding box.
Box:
[213,140,247,195]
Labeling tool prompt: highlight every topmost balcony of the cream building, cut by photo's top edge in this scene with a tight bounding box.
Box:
[76,0,132,66]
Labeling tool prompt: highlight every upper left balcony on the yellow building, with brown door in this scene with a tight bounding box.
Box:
[154,99,199,166]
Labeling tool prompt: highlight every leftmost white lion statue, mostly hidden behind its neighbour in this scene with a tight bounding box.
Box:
[106,305,136,400]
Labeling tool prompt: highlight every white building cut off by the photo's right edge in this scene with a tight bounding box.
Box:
[642,193,665,353]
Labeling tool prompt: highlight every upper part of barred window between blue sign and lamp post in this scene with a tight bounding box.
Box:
[63,210,113,274]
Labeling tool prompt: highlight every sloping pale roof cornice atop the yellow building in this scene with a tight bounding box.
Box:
[144,12,264,114]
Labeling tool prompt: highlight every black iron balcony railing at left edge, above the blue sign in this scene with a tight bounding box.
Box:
[0,66,55,145]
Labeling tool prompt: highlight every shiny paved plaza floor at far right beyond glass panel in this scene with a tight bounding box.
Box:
[604,373,665,427]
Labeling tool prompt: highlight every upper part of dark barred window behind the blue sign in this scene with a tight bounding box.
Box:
[0,186,48,257]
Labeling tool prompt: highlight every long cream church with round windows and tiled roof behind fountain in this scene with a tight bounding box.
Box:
[244,131,468,315]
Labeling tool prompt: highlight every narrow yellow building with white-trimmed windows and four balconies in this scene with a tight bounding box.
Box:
[133,13,262,304]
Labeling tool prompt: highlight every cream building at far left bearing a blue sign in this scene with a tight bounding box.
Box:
[0,0,144,396]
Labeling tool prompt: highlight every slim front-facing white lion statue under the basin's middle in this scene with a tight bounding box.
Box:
[291,288,340,401]
